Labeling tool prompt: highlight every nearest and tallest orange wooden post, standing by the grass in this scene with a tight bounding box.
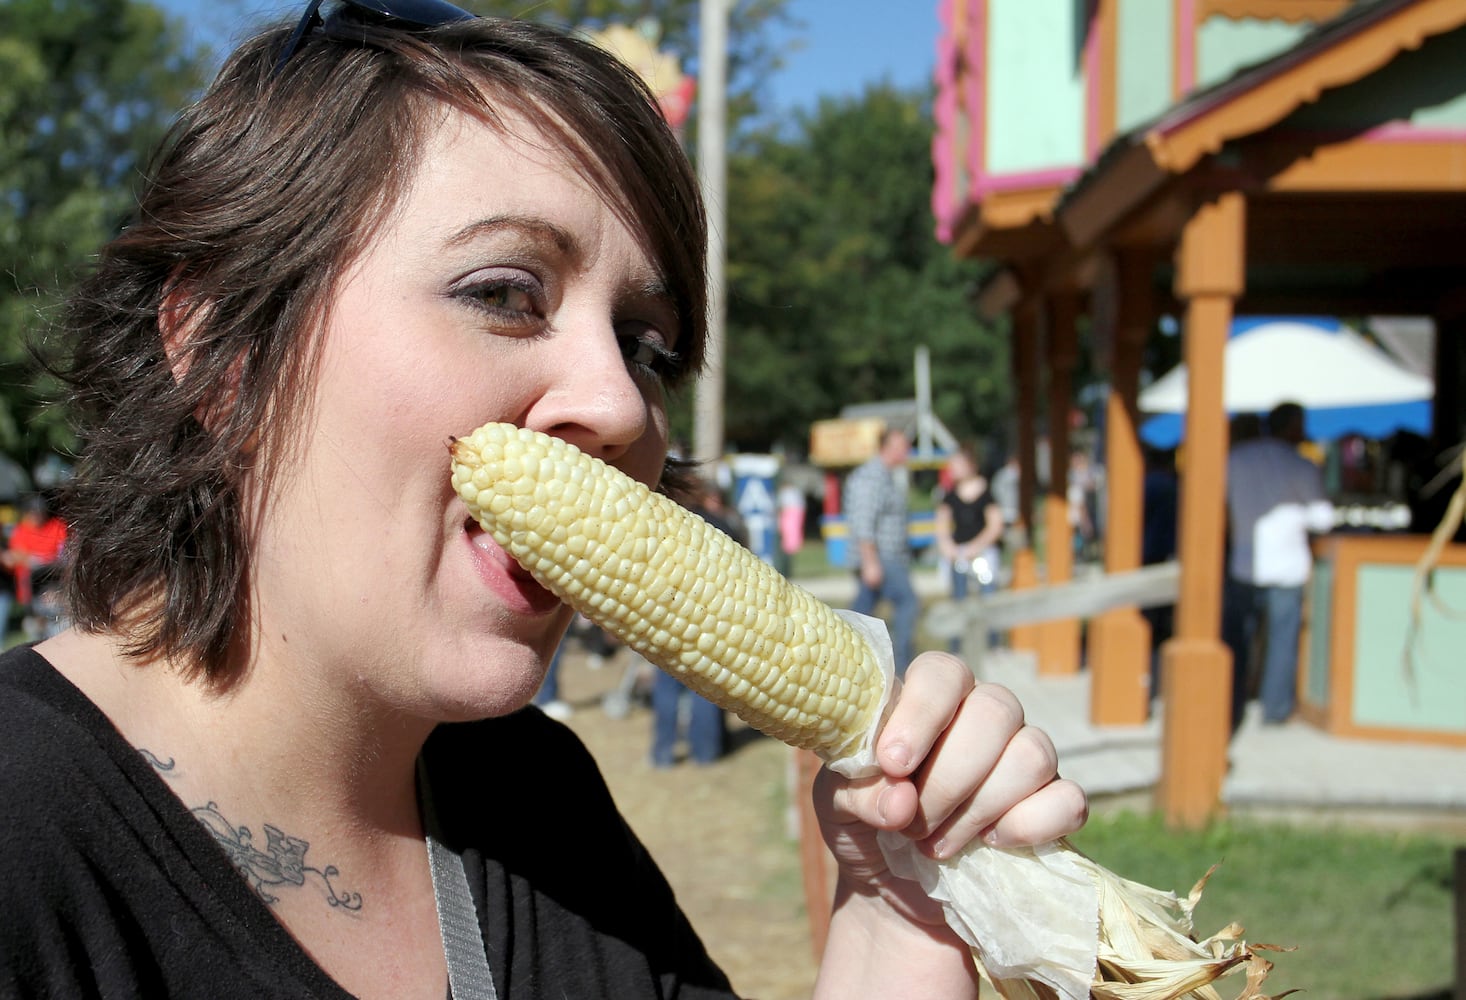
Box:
[1157,191,1246,827]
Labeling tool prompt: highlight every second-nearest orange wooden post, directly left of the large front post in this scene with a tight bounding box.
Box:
[1089,252,1155,715]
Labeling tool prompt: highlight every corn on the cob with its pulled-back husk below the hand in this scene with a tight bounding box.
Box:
[452,424,1271,1000]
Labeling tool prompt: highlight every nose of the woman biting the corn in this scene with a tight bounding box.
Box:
[525,334,649,462]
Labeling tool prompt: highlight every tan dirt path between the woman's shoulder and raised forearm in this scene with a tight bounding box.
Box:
[560,645,815,1000]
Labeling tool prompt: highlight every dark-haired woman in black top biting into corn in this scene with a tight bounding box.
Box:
[0,0,1085,1000]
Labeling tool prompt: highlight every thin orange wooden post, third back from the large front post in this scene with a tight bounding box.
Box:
[1038,293,1079,676]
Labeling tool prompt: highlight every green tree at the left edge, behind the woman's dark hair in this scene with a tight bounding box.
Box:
[0,0,212,465]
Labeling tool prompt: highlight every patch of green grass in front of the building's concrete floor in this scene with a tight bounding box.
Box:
[1073,812,1457,1000]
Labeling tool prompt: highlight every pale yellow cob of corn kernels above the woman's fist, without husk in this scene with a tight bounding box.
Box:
[453,424,884,760]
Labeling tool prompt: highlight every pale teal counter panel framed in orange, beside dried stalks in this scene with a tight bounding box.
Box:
[1350,565,1466,732]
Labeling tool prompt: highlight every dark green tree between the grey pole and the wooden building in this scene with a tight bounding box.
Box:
[712,85,1010,450]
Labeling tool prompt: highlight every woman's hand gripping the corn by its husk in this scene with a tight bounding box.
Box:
[815,652,1088,940]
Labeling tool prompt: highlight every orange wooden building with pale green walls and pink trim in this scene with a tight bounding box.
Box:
[932,0,1466,824]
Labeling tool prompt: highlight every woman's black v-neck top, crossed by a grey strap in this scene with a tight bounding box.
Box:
[0,648,733,1000]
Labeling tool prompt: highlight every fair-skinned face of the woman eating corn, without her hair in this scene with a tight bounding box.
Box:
[254,111,677,720]
